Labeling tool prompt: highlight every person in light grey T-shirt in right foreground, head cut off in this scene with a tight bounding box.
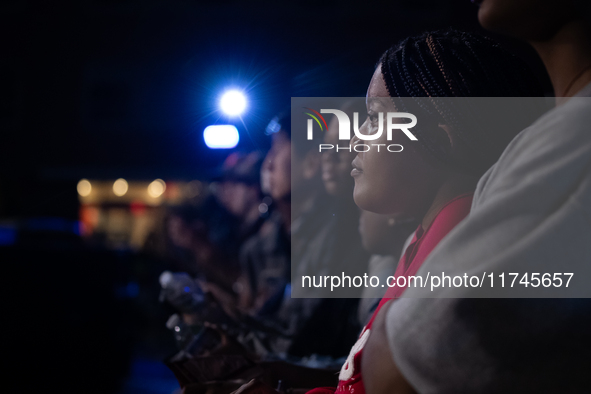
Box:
[362,0,591,394]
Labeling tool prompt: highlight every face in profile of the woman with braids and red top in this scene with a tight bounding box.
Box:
[351,65,442,218]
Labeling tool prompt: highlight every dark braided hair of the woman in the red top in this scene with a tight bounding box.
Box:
[379,29,546,176]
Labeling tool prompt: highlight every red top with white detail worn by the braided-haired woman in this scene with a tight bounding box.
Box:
[307,193,474,394]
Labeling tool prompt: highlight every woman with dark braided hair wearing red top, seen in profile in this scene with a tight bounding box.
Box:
[309,30,543,394]
